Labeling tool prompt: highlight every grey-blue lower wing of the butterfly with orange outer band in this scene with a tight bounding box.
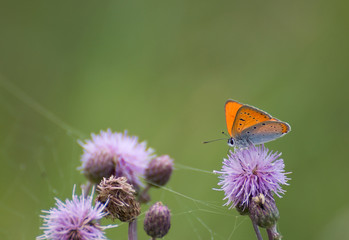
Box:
[239,121,291,145]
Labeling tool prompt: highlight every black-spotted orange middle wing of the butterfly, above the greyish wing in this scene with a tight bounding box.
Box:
[232,105,279,136]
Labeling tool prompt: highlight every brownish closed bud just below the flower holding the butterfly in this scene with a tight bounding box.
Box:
[249,193,279,228]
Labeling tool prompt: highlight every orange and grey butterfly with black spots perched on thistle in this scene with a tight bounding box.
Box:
[225,99,291,148]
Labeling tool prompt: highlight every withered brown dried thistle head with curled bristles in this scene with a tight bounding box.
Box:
[96,176,140,222]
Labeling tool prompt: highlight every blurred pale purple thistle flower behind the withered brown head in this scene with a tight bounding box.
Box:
[79,129,153,189]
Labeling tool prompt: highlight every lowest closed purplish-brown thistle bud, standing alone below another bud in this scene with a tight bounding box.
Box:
[144,202,171,238]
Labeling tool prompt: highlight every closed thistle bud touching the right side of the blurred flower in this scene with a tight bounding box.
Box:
[145,155,173,186]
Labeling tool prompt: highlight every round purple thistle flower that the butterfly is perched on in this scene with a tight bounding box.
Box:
[214,145,289,208]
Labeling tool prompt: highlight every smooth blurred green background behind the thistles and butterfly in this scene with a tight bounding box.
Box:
[0,0,349,240]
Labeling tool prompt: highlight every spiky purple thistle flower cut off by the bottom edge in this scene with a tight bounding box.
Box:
[37,187,116,240]
